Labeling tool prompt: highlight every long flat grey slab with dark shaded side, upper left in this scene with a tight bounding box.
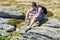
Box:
[0,8,25,19]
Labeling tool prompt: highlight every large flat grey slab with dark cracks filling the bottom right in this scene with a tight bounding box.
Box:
[15,27,60,40]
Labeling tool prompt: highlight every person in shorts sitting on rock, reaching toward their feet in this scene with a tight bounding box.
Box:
[25,2,44,32]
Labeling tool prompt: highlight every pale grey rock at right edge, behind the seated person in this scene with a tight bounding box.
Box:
[47,18,60,28]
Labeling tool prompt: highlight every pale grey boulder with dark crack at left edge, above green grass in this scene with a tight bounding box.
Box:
[0,24,15,36]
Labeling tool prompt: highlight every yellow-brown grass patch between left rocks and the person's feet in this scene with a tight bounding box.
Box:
[7,18,24,28]
